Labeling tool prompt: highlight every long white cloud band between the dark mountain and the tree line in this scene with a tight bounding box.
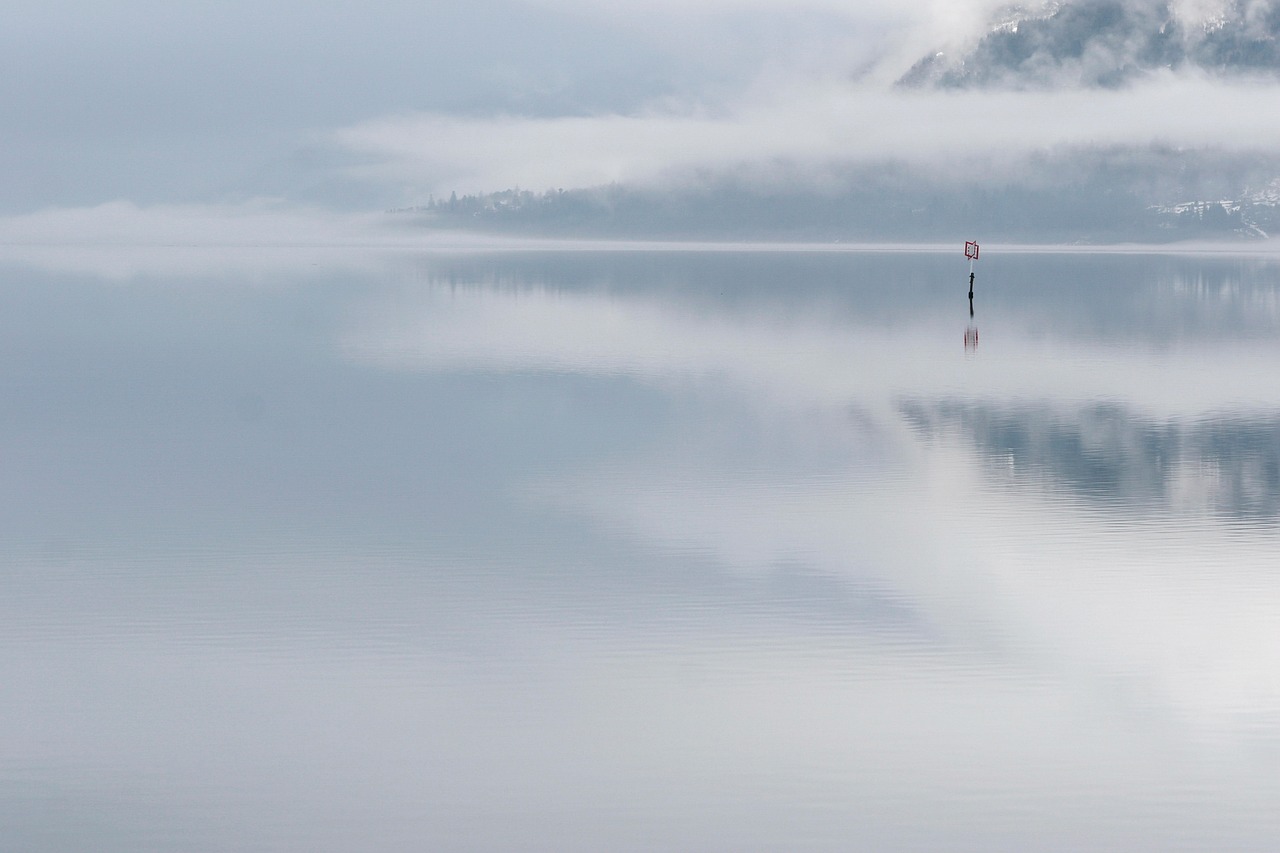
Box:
[335,73,1280,199]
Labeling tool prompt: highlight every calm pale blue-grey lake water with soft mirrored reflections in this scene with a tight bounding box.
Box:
[0,246,1280,853]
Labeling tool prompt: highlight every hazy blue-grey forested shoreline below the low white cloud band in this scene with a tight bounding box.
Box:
[398,154,1280,242]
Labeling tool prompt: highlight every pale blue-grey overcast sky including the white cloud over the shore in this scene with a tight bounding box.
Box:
[0,0,1280,225]
